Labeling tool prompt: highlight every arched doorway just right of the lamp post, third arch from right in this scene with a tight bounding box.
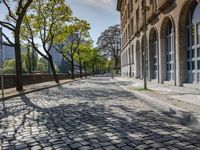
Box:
[149,28,158,80]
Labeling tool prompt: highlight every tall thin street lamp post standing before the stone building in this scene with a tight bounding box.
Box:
[141,0,149,90]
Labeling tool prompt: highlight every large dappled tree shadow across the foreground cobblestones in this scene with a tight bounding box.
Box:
[1,96,200,149]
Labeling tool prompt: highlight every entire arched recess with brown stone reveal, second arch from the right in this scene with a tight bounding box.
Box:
[159,16,176,84]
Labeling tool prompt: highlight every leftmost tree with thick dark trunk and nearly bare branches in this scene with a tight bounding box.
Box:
[0,0,33,91]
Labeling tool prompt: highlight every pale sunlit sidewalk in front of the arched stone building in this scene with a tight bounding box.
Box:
[114,77,200,127]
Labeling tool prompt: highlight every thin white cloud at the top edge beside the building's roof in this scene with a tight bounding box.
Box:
[76,0,116,10]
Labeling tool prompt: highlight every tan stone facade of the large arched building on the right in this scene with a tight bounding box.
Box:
[118,0,200,86]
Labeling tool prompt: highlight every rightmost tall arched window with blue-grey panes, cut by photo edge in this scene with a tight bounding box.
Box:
[187,2,200,83]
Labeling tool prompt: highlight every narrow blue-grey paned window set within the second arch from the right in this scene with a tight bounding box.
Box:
[165,20,174,81]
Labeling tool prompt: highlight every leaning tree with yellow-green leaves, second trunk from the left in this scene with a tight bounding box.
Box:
[22,0,72,83]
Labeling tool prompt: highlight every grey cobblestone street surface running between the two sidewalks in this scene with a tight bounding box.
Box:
[0,78,200,150]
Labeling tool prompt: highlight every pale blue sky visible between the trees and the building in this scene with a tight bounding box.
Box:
[0,0,120,44]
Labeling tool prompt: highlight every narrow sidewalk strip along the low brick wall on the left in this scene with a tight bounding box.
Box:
[0,78,80,101]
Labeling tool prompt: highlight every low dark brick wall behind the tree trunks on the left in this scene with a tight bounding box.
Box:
[0,74,79,89]
